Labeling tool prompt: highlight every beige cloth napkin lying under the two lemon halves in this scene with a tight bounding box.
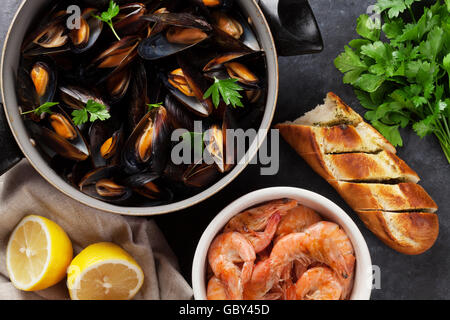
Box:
[0,160,192,300]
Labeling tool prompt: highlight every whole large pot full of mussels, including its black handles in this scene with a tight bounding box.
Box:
[0,0,322,215]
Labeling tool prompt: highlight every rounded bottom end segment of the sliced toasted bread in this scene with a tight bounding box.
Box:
[357,211,439,255]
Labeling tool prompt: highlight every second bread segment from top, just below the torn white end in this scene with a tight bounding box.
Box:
[275,122,397,154]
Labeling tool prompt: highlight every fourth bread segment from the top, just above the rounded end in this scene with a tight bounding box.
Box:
[329,181,437,212]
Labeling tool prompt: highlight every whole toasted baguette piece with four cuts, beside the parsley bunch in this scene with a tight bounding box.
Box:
[276,93,439,254]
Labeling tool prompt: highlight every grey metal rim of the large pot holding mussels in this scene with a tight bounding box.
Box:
[0,0,279,216]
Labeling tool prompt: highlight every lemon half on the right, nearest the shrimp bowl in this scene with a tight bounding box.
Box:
[67,242,144,300]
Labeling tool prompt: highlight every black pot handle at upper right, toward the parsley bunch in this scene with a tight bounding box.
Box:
[259,0,323,56]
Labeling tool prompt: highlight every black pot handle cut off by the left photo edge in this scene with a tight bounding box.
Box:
[0,103,23,176]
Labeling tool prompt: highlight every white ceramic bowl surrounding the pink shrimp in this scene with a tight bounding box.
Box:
[192,187,372,300]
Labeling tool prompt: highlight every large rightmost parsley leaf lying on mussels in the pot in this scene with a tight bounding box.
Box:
[203,77,244,108]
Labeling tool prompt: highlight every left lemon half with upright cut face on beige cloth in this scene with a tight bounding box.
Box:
[6,215,73,291]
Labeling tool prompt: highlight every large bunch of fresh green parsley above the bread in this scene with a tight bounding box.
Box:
[335,0,450,163]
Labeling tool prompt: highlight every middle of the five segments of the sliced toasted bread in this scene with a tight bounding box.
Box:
[301,151,420,183]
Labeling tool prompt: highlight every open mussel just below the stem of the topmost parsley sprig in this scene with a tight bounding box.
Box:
[82,36,141,84]
